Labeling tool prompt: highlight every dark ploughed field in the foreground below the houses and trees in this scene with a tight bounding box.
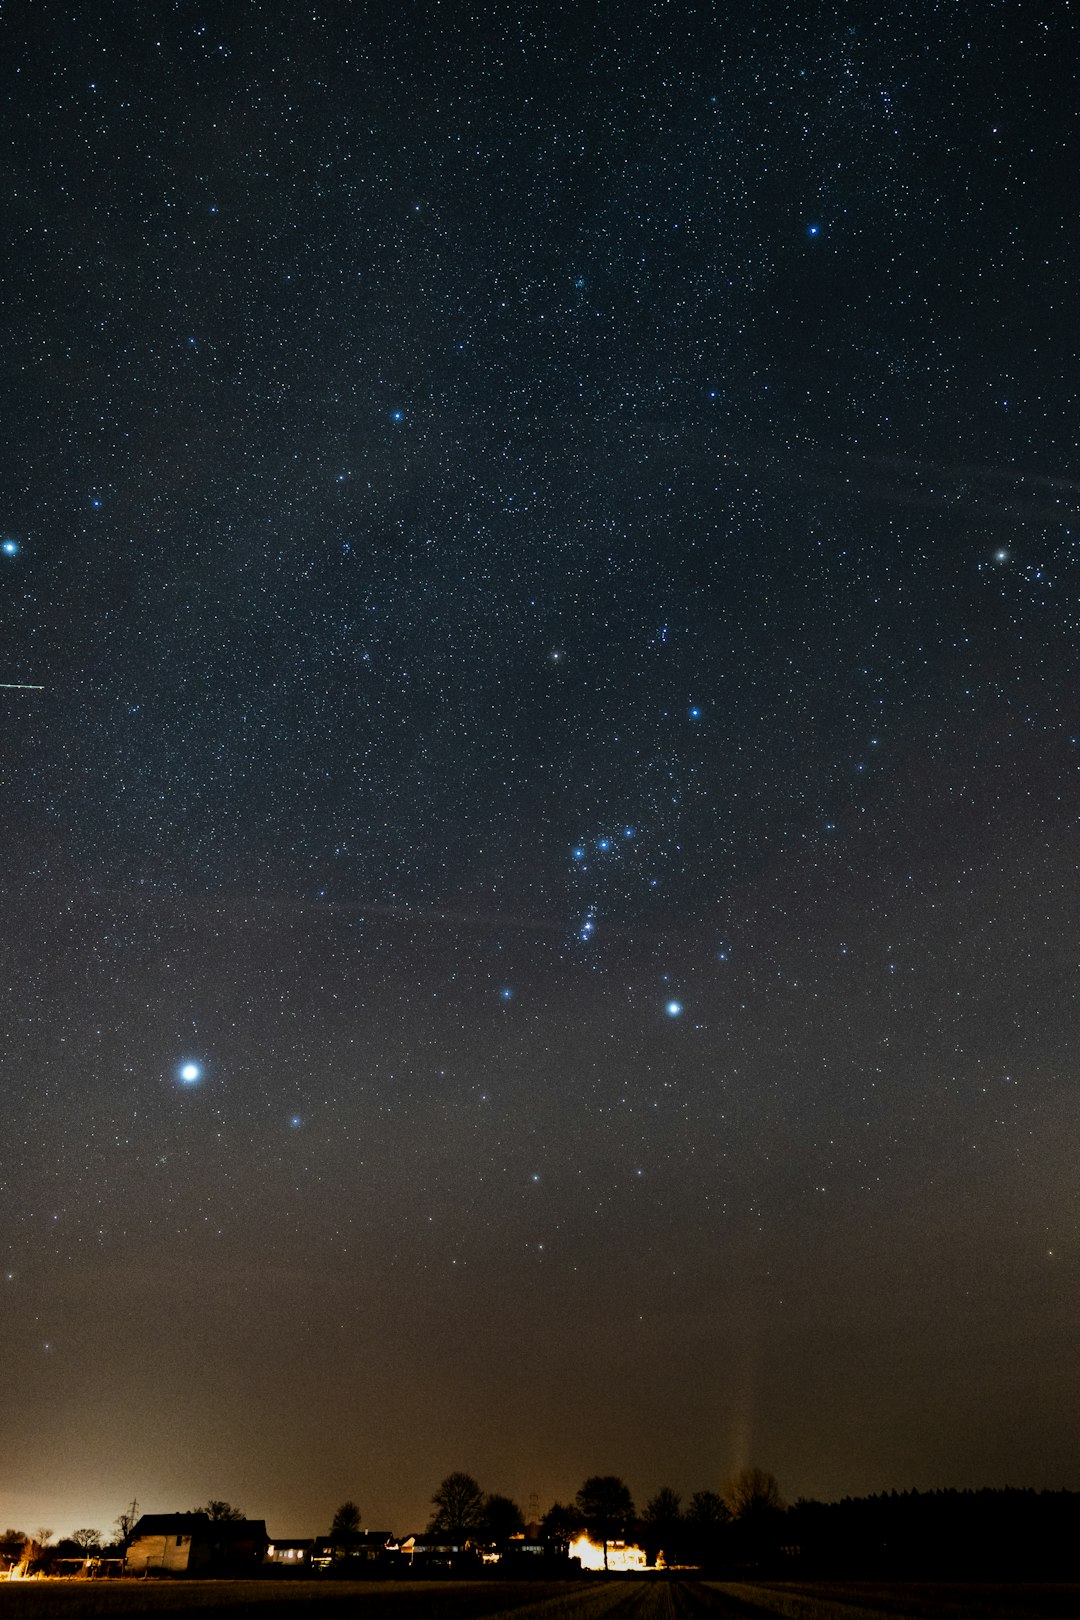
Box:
[0,1575,1080,1620]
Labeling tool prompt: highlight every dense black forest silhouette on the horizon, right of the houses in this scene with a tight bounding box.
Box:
[777,1489,1080,1580]
